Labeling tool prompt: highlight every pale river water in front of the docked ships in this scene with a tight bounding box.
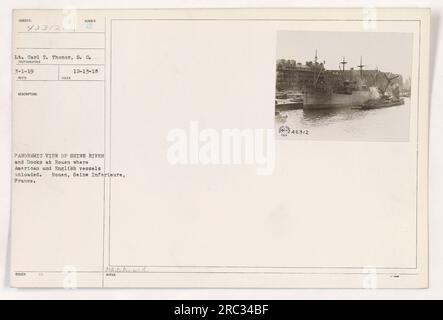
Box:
[275,98,410,141]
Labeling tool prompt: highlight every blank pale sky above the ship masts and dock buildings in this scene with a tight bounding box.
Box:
[277,31,413,78]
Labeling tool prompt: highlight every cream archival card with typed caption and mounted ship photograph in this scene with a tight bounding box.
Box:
[10,9,430,288]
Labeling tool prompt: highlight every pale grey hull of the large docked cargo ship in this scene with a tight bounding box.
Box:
[303,91,371,109]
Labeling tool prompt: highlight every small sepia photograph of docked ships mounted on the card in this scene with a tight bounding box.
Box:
[275,31,413,141]
